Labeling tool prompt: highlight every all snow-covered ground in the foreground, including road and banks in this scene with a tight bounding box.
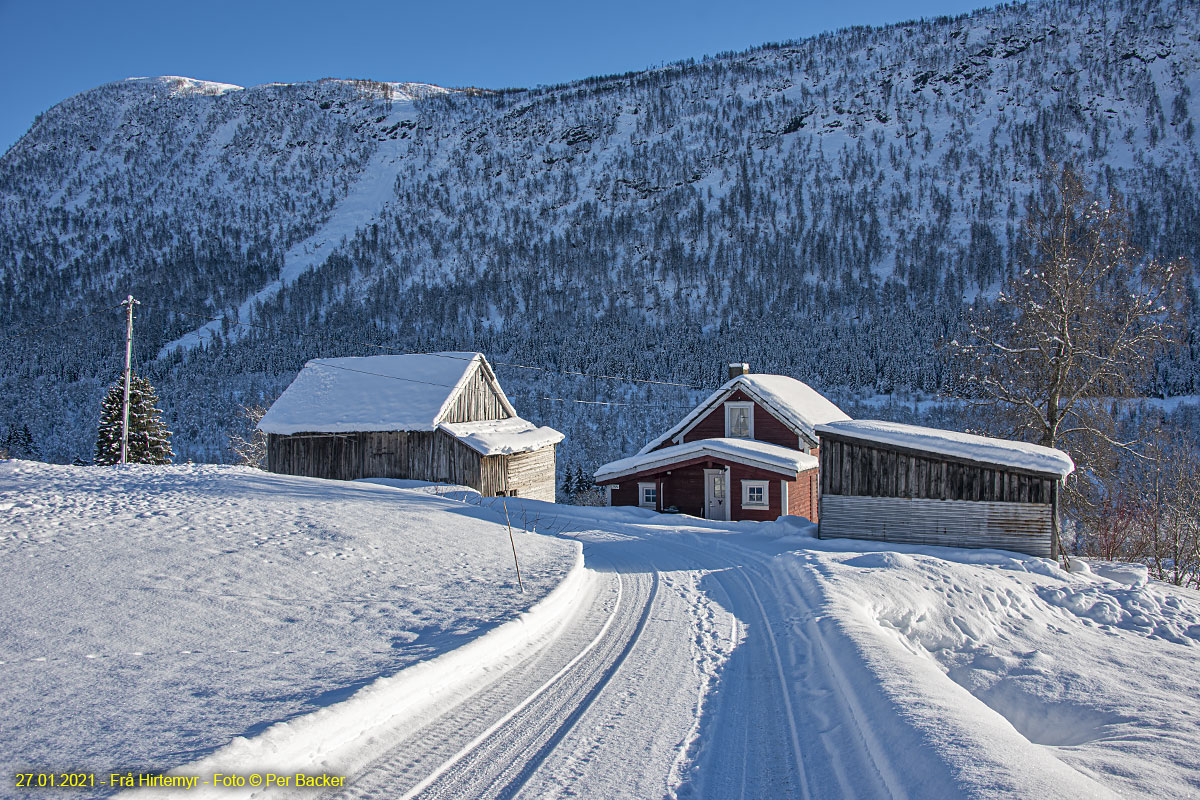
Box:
[0,462,1200,798]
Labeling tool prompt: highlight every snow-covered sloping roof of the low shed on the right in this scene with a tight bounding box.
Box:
[817,420,1075,477]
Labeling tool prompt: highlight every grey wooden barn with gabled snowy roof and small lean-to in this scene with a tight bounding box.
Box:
[258,353,563,503]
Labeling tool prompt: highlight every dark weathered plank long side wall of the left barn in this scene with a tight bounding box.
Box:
[266,431,487,494]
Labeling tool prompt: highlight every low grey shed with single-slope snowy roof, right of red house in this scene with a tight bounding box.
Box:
[816,420,1075,558]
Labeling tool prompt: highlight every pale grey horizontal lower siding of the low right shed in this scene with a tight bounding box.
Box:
[820,494,1054,558]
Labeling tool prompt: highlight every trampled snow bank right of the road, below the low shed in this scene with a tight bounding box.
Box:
[778,542,1200,798]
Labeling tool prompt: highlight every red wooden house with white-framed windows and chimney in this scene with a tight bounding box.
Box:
[595,363,850,522]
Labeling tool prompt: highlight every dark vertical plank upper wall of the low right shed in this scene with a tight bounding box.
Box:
[820,434,1056,504]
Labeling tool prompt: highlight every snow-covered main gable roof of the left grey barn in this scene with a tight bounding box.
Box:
[258,353,516,434]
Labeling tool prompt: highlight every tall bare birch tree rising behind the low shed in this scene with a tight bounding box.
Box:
[952,167,1190,504]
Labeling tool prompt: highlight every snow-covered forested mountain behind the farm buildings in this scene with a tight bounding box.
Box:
[0,0,1200,465]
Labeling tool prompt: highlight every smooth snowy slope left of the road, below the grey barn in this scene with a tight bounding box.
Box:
[0,462,577,796]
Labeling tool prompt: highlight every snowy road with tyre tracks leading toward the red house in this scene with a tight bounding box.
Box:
[319,524,906,799]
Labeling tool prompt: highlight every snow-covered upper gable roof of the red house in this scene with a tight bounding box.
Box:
[638,374,850,455]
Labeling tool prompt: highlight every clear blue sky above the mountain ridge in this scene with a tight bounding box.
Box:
[0,0,983,152]
